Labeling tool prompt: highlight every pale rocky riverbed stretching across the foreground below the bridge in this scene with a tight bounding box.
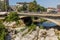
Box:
[5,28,60,40]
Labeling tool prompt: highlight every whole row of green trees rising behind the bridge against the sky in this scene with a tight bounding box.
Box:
[17,0,47,12]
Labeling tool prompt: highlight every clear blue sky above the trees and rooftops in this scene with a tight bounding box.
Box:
[9,0,60,8]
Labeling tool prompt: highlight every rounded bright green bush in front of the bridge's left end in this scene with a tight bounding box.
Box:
[5,12,19,22]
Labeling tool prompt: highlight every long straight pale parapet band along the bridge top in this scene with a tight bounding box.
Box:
[18,13,60,17]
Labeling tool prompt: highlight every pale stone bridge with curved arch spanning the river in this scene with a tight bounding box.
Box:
[0,13,60,26]
